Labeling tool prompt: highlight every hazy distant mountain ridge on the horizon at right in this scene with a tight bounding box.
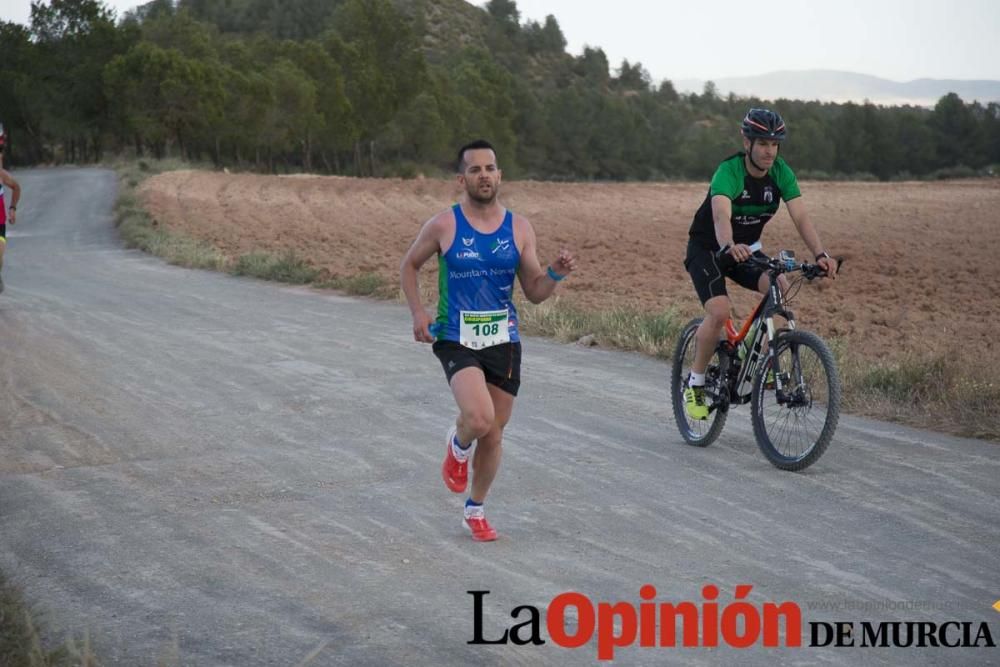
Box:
[674,70,1000,107]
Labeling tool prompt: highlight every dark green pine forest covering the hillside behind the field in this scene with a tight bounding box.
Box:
[0,0,1000,180]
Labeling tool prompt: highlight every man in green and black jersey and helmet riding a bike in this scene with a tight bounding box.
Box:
[684,108,837,420]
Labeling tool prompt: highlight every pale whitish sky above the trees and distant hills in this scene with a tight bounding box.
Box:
[0,0,1000,81]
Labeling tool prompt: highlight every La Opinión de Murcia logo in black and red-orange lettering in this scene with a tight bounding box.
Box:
[467,584,1000,660]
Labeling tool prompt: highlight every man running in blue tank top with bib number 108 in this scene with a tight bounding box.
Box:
[400,141,576,542]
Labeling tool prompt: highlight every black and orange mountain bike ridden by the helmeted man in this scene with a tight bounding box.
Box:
[670,250,840,470]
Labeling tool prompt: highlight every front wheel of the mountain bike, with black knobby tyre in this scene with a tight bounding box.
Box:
[750,331,840,470]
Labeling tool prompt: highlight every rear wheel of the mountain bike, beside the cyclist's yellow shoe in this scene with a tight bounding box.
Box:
[670,317,727,447]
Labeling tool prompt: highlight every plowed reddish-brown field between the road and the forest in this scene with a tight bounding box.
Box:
[142,171,1000,363]
